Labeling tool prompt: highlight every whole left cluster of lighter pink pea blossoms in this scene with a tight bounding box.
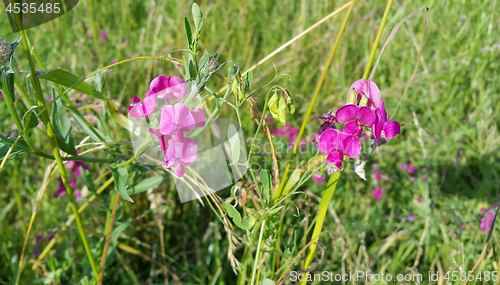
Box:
[129,75,205,177]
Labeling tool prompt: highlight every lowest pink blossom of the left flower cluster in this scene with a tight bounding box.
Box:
[163,132,198,178]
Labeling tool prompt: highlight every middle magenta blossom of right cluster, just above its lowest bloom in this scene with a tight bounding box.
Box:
[335,104,375,137]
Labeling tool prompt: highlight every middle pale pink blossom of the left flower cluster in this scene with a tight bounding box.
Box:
[160,103,205,135]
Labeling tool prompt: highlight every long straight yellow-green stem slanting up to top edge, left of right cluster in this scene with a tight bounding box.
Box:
[272,0,356,201]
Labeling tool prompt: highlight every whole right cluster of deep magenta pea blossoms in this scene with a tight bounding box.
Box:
[315,79,401,169]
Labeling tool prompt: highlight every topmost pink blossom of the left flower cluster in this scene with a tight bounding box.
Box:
[149,75,186,101]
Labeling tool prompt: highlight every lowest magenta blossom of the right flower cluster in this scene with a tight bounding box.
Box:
[319,129,361,168]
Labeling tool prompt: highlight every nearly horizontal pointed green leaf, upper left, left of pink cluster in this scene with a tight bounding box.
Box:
[37,69,106,100]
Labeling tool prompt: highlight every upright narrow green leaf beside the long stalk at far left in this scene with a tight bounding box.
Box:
[52,97,78,155]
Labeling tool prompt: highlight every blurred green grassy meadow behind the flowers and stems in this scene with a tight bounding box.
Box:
[0,0,500,284]
